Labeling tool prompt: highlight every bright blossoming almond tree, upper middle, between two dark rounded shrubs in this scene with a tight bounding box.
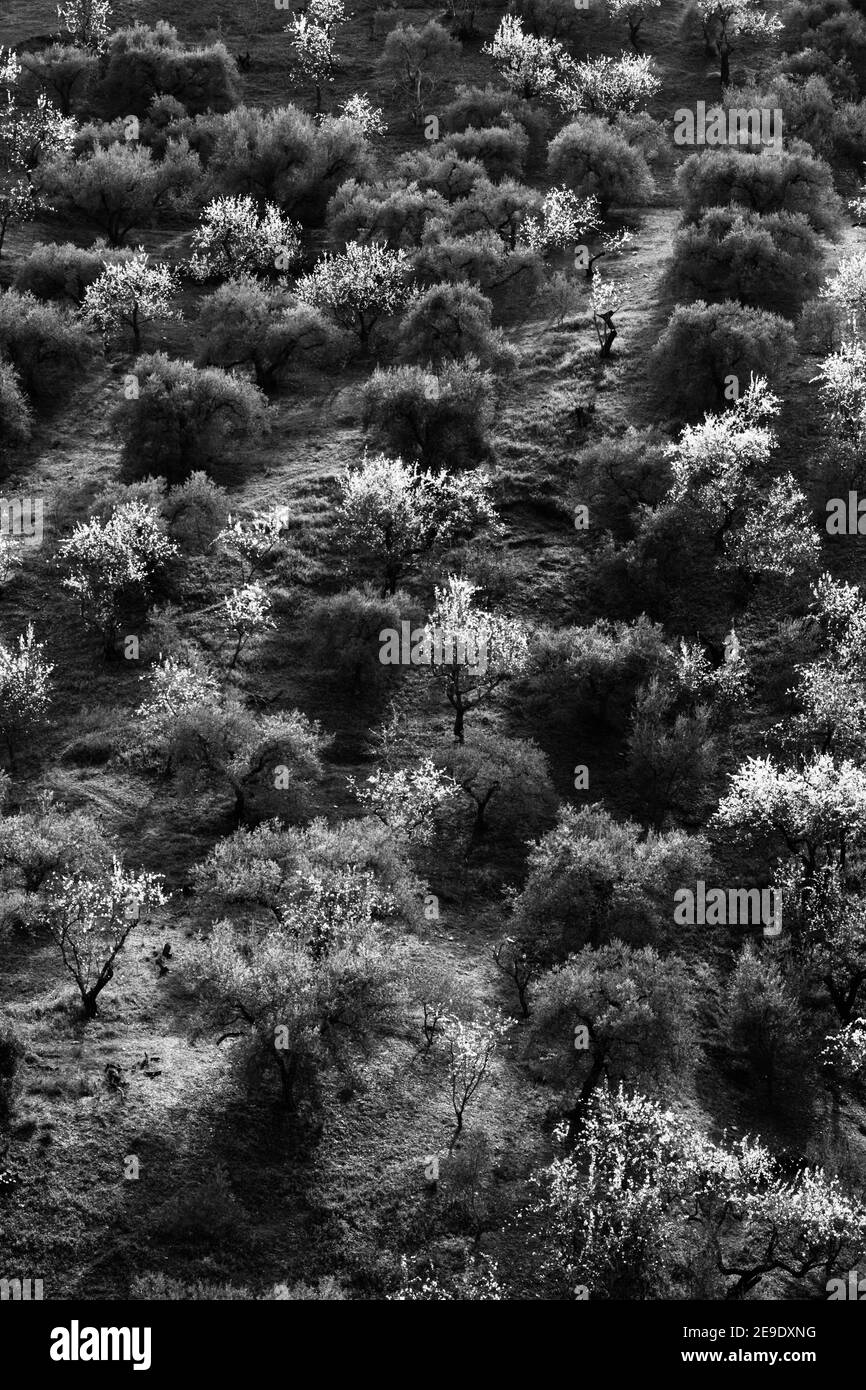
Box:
[295,242,413,348]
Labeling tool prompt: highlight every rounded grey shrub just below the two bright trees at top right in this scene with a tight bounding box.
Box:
[548,115,655,211]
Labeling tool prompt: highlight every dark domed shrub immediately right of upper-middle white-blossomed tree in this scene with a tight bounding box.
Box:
[398,285,512,368]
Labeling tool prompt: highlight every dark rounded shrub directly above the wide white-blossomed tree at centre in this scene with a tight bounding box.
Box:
[363,359,493,468]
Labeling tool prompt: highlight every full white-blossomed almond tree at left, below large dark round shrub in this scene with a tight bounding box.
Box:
[58,502,178,655]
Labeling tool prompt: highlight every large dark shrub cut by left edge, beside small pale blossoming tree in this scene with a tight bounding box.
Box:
[0,289,90,399]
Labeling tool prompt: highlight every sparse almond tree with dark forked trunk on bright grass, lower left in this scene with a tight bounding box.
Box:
[49,859,168,1019]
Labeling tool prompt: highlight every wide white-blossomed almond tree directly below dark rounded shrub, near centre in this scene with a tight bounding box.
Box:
[336,455,498,596]
